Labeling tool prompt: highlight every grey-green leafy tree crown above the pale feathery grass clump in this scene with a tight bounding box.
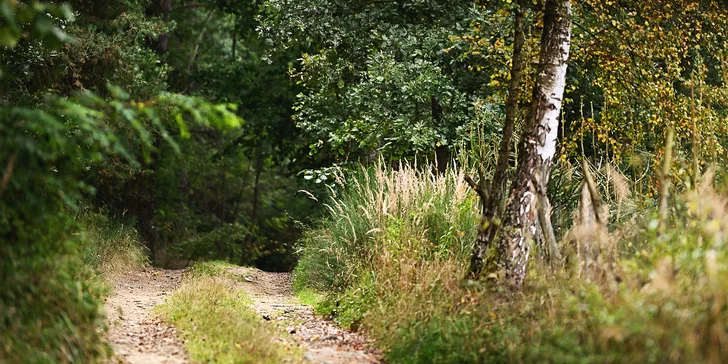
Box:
[261,0,486,160]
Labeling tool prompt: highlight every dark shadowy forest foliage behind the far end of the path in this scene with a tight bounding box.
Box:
[93,1,322,270]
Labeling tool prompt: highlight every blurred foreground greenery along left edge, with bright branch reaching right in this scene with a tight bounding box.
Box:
[0,1,247,362]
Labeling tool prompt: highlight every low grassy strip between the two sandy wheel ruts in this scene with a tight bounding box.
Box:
[157,262,296,363]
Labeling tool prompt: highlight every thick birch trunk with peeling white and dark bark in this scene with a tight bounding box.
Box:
[501,0,571,289]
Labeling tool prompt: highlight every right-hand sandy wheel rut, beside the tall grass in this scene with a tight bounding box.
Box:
[227,267,382,364]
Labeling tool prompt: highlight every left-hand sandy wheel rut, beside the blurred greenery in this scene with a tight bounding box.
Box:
[104,268,189,364]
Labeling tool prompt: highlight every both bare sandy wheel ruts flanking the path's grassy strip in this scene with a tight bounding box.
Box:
[105,267,382,364]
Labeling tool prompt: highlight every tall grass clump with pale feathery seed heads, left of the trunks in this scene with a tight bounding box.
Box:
[295,164,478,291]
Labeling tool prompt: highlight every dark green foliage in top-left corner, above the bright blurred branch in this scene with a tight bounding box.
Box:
[0,1,168,102]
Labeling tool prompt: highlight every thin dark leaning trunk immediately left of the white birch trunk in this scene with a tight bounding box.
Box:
[468,0,526,276]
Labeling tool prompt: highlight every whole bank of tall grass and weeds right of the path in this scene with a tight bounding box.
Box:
[295,165,728,363]
